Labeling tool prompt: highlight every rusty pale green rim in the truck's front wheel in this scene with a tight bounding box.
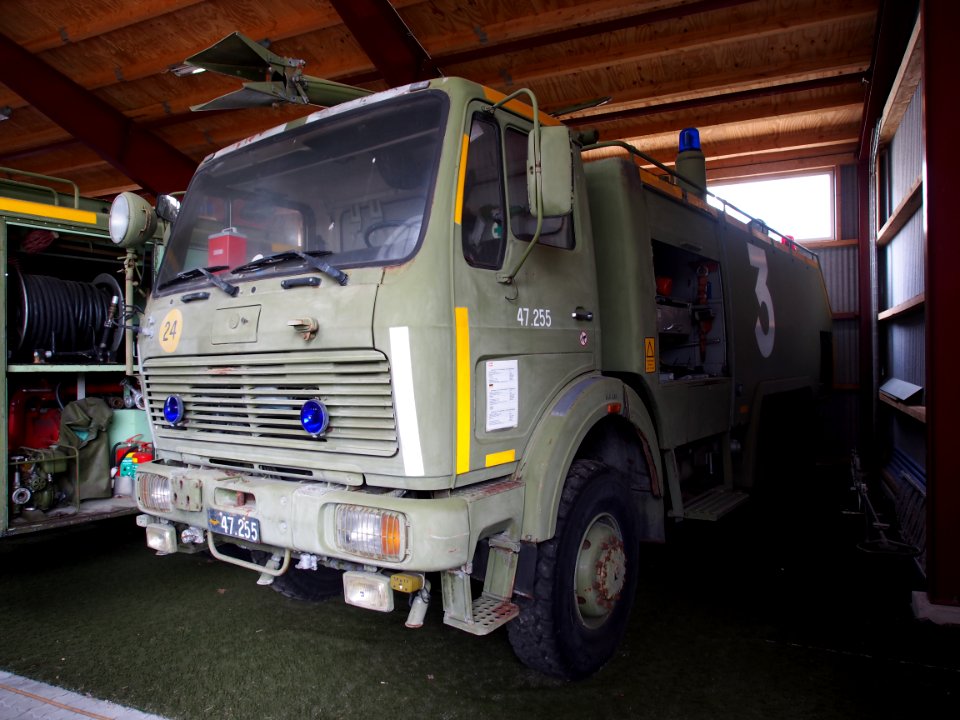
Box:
[574,513,627,628]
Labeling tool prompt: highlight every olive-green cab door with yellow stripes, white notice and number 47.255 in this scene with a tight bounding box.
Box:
[453,104,600,483]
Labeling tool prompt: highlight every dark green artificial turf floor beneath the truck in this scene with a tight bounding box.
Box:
[0,466,960,720]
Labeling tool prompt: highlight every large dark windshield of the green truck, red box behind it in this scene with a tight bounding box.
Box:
[155,92,447,292]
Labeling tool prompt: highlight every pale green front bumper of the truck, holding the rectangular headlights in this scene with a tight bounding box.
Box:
[137,463,523,572]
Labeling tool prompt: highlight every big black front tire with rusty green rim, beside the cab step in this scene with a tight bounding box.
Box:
[507,460,640,680]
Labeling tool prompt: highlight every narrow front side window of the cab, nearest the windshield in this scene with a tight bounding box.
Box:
[461,114,506,270]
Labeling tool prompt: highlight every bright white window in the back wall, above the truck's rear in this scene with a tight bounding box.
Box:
[708,172,835,241]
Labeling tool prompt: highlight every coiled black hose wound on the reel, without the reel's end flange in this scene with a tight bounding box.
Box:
[10,273,111,357]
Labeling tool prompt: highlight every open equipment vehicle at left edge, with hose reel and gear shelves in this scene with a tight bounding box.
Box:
[0,168,150,536]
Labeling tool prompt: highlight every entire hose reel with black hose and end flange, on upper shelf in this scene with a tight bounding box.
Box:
[8,268,125,362]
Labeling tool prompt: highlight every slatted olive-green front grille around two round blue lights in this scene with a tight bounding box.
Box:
[143,350,397,467]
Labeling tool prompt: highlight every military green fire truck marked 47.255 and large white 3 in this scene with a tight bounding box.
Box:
[115,36,832,678]
